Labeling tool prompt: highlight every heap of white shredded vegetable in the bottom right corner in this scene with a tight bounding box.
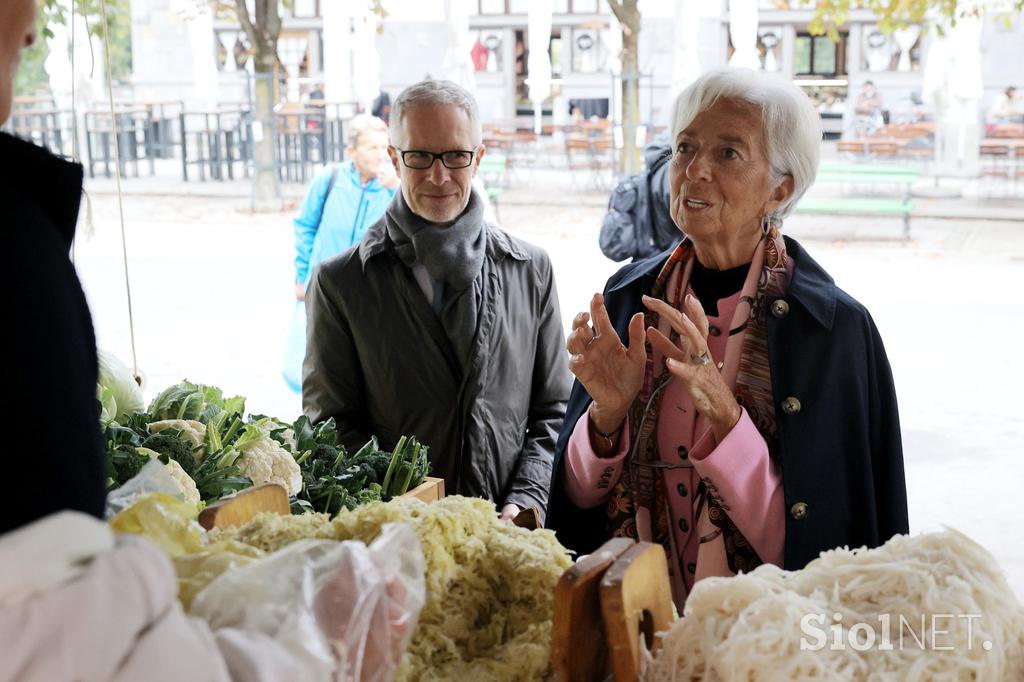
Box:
[644,530,1024,682]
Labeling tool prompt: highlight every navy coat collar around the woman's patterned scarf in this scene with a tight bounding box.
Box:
[608,236,837,329]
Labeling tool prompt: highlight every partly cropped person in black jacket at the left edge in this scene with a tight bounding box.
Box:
[0,0,106,534]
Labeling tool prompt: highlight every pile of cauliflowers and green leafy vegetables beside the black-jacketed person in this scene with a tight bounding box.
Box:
[96,368,430,514]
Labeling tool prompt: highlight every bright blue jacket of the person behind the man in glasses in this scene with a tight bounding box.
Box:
[295,161,396,285]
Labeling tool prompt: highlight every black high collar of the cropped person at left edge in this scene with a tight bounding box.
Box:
[0,133,83,249]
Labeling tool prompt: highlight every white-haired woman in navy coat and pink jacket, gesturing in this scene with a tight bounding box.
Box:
[549,69,907,608]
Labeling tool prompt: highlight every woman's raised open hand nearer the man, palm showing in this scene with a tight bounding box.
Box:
[565,294,647,432]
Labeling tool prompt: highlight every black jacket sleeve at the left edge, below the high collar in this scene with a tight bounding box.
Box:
[0,188,106,532]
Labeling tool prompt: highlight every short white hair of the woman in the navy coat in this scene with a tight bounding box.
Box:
[672,68,821,220]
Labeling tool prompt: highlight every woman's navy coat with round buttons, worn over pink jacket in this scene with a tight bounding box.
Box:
[548,238,908,569]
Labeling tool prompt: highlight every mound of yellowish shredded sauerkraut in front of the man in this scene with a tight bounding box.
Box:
[211,497,571,682]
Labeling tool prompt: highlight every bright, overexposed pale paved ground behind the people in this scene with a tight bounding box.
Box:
[75,168,1024,599]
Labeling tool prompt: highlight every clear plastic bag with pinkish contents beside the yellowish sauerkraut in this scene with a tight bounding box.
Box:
[191,523,426,682]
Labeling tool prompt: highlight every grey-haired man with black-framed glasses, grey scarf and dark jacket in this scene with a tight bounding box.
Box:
[302,80,570,520]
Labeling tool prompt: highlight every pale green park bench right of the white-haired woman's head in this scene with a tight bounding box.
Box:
[797,162,921,239]
